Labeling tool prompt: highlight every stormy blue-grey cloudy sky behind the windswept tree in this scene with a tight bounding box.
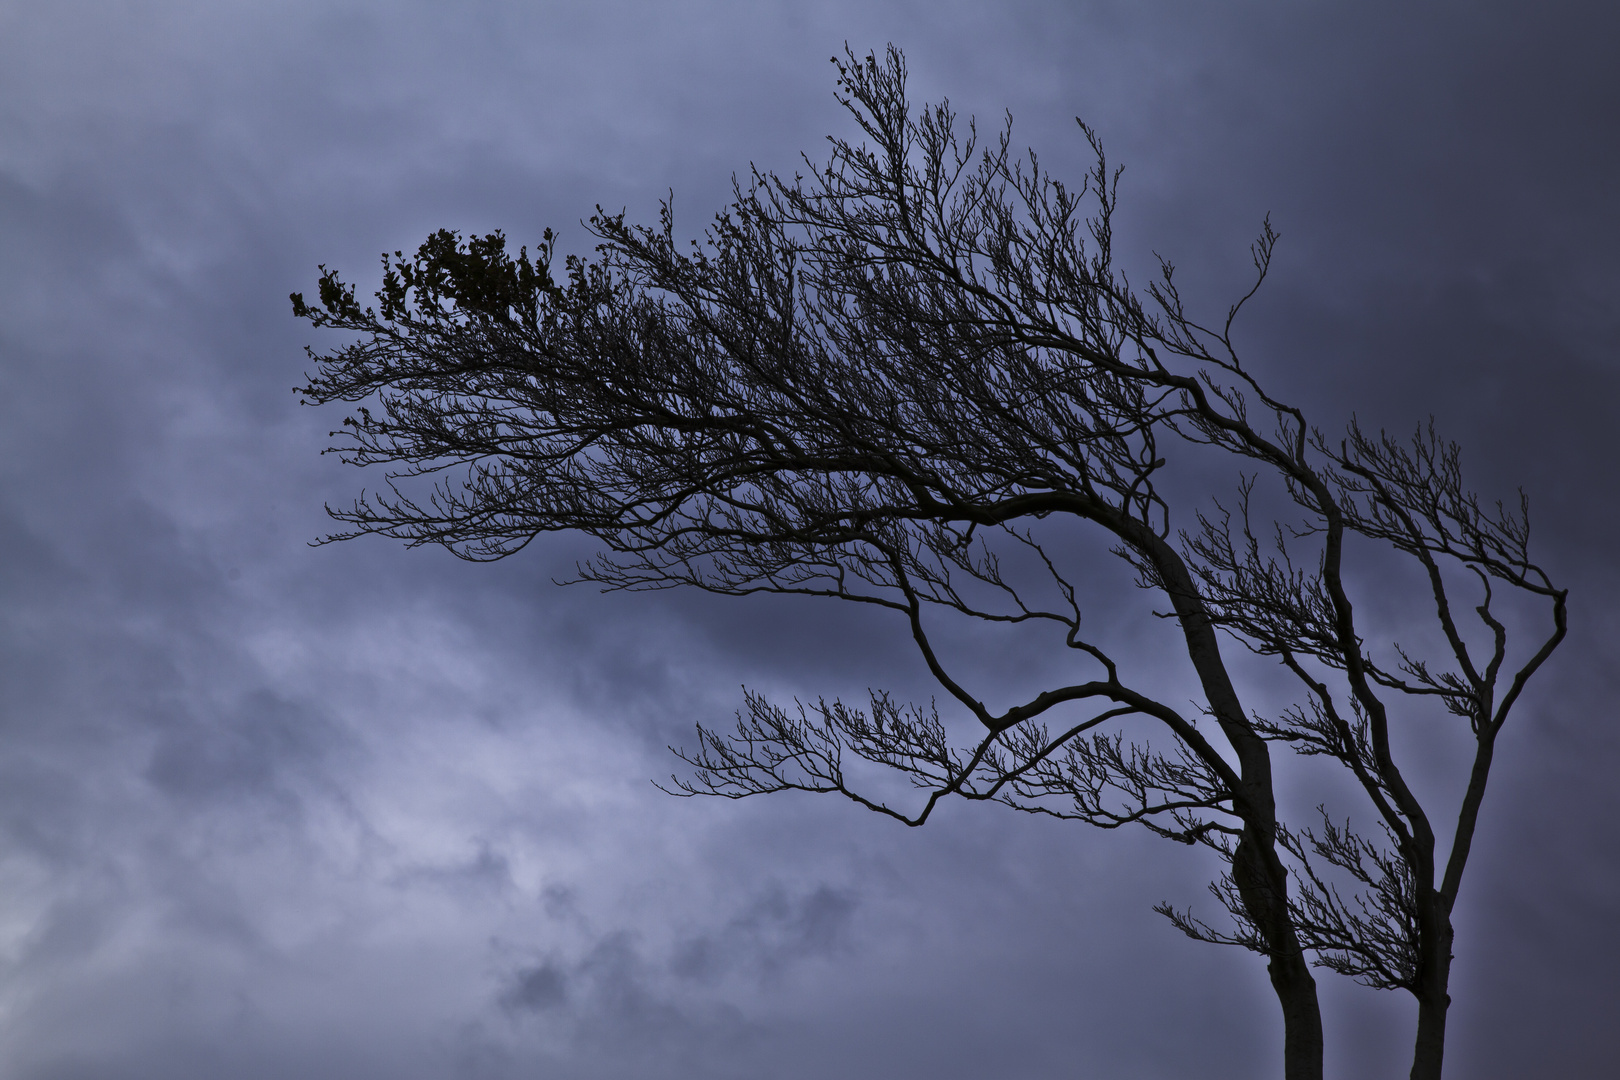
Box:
[0,0,1620,1080]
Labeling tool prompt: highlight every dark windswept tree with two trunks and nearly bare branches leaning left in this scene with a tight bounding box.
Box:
[292,49,1565,1080]
